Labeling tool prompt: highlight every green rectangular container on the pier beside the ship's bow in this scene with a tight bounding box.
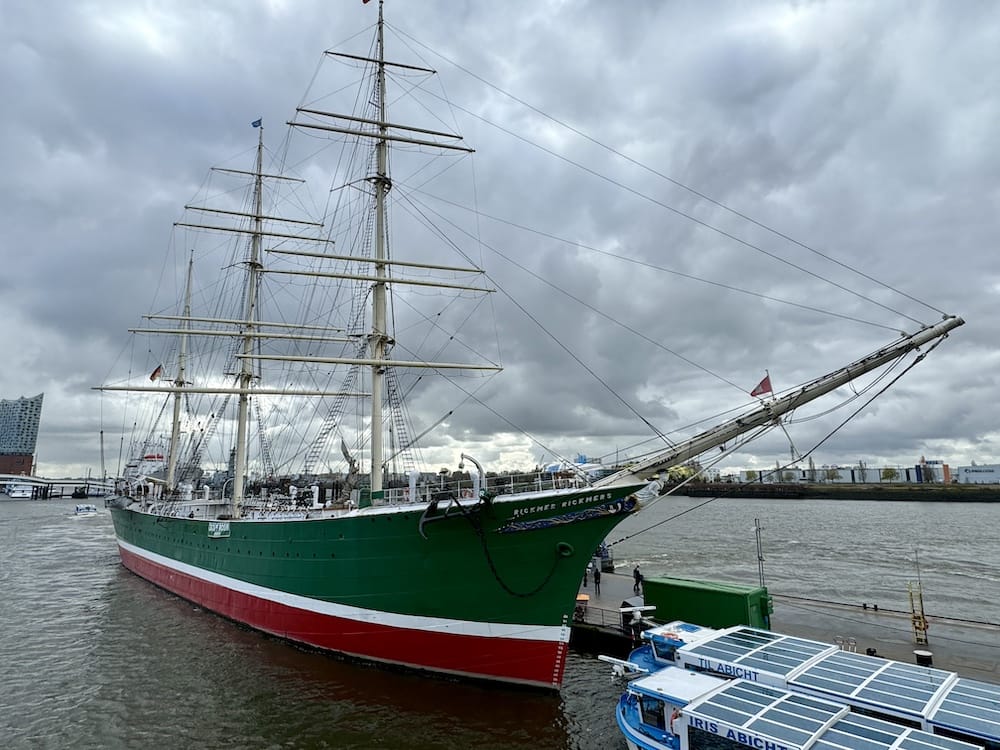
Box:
[642,578,774,629]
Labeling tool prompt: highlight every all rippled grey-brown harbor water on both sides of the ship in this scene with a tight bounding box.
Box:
[0,498,1000,750]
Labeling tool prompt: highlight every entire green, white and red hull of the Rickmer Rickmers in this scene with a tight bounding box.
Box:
[112,485,640,689]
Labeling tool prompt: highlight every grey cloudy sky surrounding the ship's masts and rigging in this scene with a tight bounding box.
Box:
[0,0,1000,476]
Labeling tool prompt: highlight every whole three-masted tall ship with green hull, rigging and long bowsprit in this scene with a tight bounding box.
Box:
[99,2,962,689]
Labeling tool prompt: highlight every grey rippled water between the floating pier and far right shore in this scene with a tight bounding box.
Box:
[610,498,1000,623]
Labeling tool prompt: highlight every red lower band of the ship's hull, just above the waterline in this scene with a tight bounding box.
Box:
[119,546,567,689]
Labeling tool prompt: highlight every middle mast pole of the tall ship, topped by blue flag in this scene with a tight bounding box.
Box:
[230,124,264,518]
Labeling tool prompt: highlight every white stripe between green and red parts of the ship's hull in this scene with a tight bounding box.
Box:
[118,539,569,642]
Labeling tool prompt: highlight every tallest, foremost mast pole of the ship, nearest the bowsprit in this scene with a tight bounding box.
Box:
[370,0,391,500]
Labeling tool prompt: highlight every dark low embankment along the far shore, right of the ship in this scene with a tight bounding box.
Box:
[677,482,1000,503]
